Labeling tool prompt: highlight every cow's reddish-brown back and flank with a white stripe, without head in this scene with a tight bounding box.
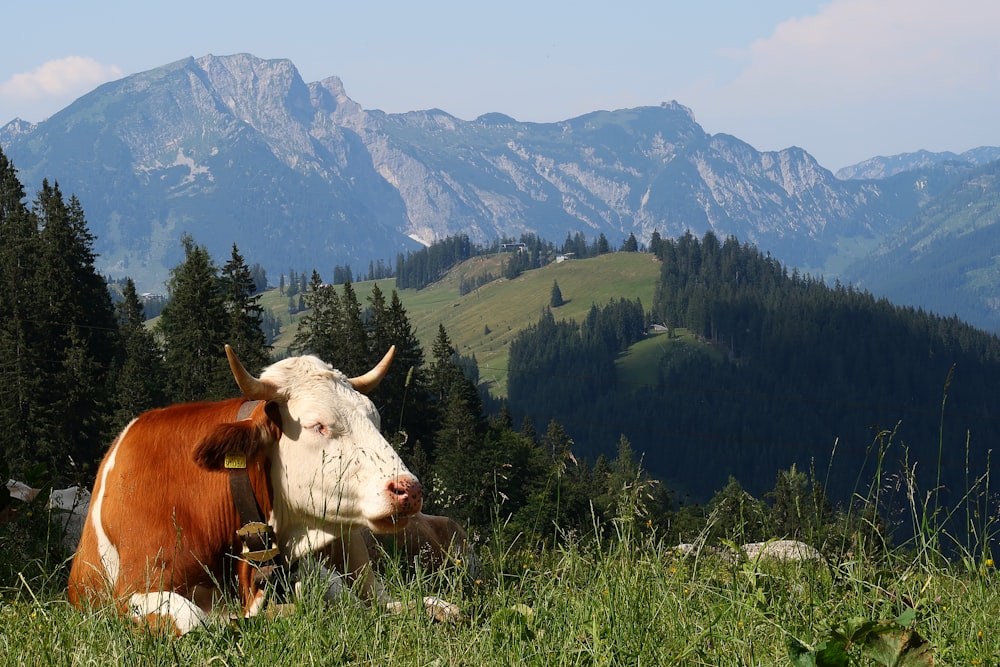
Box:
[69,399,270,605]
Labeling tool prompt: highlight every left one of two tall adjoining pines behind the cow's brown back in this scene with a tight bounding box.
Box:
[158,235,233,402]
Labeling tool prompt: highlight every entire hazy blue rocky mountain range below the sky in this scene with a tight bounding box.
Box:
[0,54,924,289]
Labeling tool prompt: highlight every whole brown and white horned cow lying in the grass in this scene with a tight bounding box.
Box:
[69,346,450,634]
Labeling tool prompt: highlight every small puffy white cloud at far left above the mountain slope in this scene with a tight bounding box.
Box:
[0,56,123,104]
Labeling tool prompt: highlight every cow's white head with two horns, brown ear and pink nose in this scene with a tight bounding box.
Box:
[198,345,422,552]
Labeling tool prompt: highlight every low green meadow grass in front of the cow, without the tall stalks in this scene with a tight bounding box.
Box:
[0,533,1000,667]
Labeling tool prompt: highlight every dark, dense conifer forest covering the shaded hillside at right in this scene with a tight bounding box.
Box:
[510,233,1000,520]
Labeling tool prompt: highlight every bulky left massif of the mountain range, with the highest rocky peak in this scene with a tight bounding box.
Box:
[0,55,418,289]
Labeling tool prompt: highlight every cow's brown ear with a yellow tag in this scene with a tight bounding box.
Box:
[194,403,281,470]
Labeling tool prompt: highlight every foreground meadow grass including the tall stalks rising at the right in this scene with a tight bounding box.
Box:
[0,400,1000,667]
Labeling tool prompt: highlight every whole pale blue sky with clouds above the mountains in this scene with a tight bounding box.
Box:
[0,0,1000,171]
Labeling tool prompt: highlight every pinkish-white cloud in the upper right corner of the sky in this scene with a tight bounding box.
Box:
[726,0,1000,110]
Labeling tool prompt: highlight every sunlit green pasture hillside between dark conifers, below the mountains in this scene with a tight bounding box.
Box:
[261,252,660,396]
